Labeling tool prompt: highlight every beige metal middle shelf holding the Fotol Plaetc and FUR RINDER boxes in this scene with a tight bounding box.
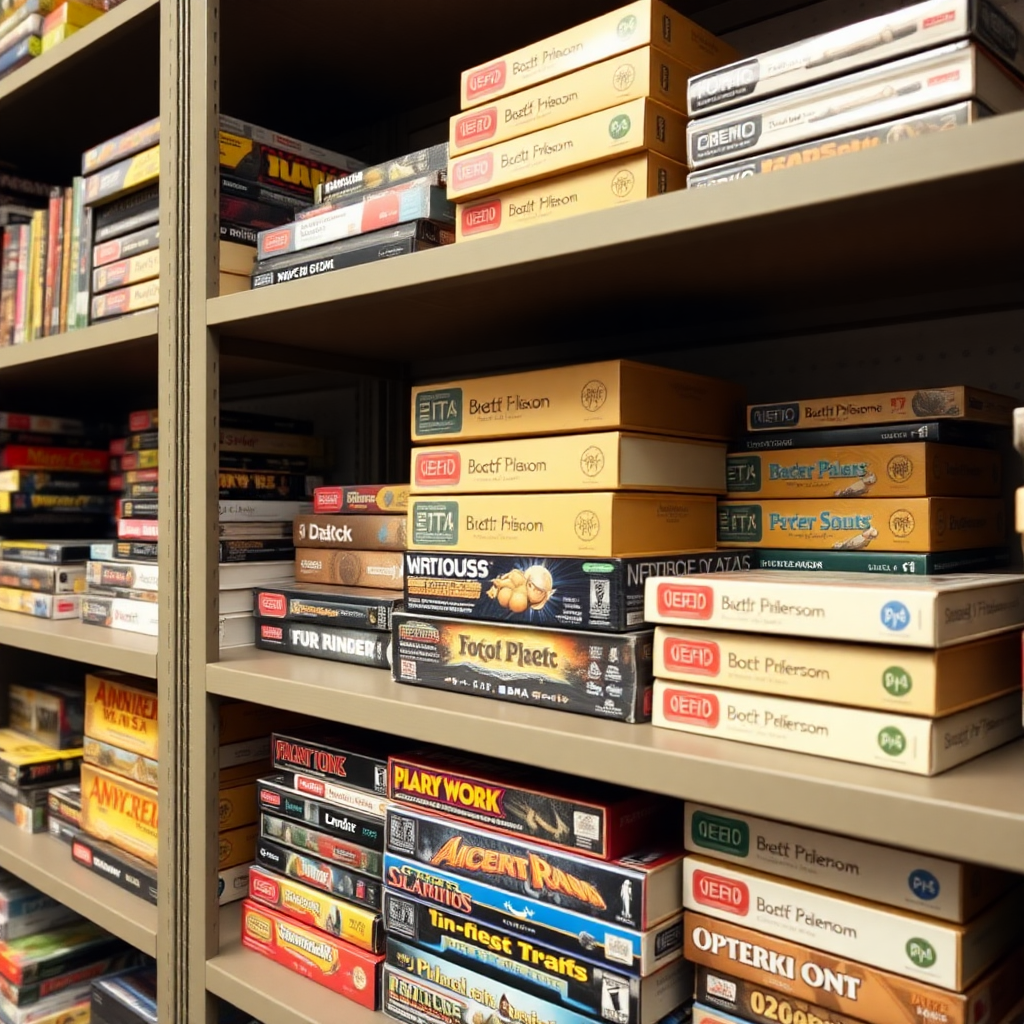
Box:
[207,647,1024,870]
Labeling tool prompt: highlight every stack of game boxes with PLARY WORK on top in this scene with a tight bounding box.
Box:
[382,749,693,1024]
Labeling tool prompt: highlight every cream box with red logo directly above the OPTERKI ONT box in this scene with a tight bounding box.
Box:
[683,856,1024,992]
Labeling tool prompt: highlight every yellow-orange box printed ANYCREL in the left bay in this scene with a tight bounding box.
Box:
[82,764,159,866]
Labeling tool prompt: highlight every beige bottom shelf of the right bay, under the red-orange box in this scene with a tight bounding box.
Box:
[206,902,382,1024]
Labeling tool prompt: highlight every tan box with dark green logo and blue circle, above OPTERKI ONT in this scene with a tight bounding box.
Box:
[684,804,1017,924]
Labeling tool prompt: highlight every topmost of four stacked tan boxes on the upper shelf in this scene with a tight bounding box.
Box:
[461,0,737,110]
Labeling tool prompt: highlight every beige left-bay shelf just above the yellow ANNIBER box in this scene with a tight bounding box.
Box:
[0,611,157,679]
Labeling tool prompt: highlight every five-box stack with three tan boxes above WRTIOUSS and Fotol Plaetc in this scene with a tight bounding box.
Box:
[392,360,750,722]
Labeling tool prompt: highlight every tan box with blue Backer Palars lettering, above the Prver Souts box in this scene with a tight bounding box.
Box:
[727,441,1002,498]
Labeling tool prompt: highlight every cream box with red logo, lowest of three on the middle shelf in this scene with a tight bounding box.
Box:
[653,680,1024,775]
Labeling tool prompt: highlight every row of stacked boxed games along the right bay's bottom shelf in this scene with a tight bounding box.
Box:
[230,730,1022,1024]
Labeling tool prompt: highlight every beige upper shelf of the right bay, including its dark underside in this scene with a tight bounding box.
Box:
[207,113,1024,364]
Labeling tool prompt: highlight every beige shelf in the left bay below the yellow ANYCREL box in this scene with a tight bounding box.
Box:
[0,821,157,956]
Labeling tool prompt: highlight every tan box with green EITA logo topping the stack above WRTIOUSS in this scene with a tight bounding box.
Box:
[413,359,742,444]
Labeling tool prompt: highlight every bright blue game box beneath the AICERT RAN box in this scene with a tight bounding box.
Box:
[384,853,683,977]
